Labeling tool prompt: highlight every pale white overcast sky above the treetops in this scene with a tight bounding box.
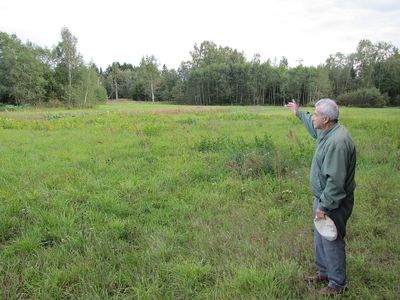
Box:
[0,0,400,68]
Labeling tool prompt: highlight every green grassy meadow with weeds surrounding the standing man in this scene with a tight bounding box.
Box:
[0,102,400,299]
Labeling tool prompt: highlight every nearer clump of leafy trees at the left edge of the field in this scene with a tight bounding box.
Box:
[0,28,107,106]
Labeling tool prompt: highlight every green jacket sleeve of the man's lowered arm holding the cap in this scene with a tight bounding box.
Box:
[319,146,347,212]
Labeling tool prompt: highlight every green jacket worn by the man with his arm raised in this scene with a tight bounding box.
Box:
[296,111,356,213]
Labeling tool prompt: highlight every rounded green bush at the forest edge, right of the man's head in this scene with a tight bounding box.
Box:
[337,87,388,107]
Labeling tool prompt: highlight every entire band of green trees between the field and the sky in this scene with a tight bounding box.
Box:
[0,28,400,107]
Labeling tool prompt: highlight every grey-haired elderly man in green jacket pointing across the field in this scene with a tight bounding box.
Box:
[287,99,356,296]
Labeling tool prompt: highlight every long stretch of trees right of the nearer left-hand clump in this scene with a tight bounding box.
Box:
[78,40,400,107]
